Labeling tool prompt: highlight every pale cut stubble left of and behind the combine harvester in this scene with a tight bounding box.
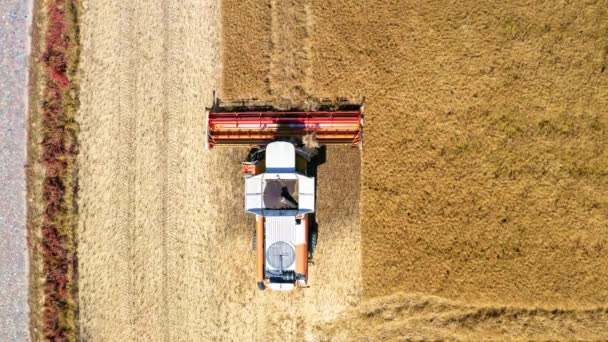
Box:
[79,1,359,341]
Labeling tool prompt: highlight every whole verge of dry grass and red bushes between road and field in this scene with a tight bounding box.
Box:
[27,0,79,341]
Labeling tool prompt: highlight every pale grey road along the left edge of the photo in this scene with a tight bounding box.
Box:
[0,0,32,341]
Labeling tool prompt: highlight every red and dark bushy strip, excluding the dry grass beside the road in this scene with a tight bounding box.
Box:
[39,0,78,341]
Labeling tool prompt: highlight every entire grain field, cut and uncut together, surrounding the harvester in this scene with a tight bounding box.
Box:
[78,0,608,341]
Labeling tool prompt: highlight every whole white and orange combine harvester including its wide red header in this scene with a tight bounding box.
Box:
[206,97,363,290]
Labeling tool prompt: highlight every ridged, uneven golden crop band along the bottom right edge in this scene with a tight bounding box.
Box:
[317,293,608,341]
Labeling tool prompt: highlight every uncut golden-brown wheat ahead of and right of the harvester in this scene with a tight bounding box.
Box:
[222,0,608,340]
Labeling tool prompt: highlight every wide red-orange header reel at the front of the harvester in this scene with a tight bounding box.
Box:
[206,93,363,148]
